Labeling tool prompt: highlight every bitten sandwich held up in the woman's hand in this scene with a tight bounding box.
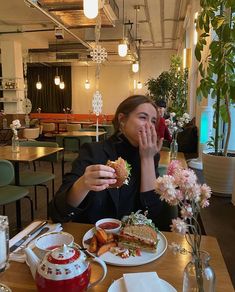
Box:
[107,157,131,188]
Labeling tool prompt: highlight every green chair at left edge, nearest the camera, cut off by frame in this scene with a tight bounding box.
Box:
[0,160,34,226]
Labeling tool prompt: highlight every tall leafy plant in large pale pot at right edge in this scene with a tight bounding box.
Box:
[195,0,235,194]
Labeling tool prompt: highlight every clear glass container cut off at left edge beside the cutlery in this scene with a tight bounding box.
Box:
[0,216,11,292]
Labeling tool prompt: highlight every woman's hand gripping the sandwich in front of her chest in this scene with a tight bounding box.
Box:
[82,164,117,192]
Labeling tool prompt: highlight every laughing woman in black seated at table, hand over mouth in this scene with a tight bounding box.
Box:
[50,95,177,230]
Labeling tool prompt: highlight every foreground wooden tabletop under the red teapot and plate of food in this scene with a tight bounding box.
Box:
[0,223,234,292]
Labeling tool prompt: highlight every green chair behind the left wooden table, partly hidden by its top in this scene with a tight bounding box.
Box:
[17,141,59,217]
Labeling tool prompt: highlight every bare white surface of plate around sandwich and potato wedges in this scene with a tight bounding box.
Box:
[82,228,167,266]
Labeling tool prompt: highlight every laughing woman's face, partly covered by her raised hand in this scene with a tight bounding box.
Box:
[119,103,157,146]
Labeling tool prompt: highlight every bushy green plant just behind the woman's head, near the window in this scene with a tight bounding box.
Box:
[145,55,188,116]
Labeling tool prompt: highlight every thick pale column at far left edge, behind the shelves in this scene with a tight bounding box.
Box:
[0,41,24,114]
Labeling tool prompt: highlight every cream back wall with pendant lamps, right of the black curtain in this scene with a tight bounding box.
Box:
[72,50,175,114]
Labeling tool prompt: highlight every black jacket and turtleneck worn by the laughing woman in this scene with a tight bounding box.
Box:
[49,135,175,230]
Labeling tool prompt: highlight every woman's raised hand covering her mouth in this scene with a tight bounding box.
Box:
[139,123,163,158]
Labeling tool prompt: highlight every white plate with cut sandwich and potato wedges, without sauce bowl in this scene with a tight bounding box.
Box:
[82,212,167,266]
